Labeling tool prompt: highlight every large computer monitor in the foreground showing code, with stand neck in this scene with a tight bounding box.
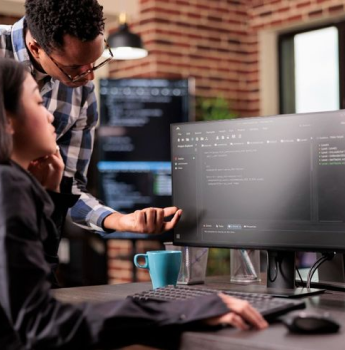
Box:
[171,110,345,288]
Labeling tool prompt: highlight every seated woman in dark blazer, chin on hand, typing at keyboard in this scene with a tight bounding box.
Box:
[0,59,267,350]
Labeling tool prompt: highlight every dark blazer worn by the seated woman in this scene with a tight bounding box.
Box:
[0,162,228,350]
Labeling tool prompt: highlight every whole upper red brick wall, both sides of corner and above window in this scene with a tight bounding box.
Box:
[111,0,345,116]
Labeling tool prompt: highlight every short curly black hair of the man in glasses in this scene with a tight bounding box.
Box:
[25,0,104,54]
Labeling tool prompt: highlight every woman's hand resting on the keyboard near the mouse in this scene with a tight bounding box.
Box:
[205,293,268,330]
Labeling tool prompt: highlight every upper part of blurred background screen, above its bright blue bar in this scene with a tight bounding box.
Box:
[97,79,193,161]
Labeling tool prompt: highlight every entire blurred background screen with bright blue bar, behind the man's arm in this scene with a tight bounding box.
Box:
[94,79,194,241]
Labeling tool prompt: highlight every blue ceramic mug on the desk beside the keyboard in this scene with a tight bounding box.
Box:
[134,250,182,289]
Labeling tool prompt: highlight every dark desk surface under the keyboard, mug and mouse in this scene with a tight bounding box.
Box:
[52,278,345,350]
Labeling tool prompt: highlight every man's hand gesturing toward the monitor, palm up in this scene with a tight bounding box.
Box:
[103,207,182,233]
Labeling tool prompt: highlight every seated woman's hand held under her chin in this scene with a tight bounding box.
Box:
[28,146,65,192]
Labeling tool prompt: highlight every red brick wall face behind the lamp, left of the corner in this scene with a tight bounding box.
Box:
[111,0,254,114]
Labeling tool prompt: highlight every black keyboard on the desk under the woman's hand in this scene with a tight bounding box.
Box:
[129,286,305,321]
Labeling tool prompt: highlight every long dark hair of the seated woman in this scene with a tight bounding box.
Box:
[0,58,28,163]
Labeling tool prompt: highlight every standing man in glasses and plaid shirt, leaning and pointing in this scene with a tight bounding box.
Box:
[0,0,182,233]
